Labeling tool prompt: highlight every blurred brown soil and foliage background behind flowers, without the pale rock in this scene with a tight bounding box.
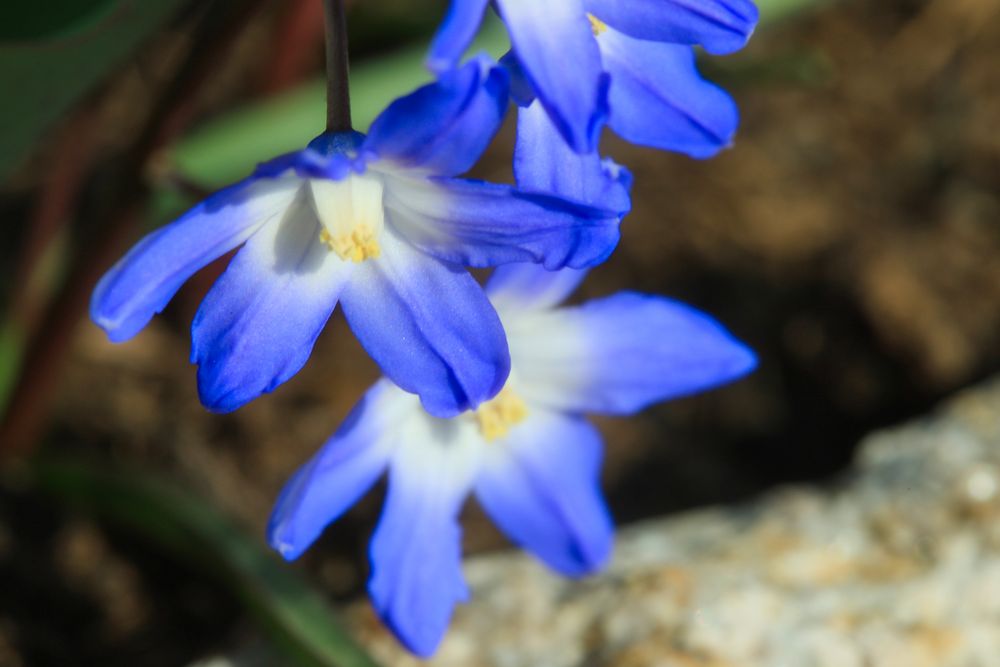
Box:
[0,0,1000,667]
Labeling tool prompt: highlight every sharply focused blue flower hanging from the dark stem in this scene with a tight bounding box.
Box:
[91,58,622,417]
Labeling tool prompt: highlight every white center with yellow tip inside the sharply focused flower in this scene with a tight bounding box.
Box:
[309,175,385,262]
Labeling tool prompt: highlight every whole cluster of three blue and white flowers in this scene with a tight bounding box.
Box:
[91,0,757,655]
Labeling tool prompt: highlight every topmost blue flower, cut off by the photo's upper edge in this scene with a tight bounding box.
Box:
[428,0,757,157]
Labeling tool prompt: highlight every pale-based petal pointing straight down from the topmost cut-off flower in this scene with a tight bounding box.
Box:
[496,0,608,152]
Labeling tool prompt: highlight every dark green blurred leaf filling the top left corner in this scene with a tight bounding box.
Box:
[0,0,188,179]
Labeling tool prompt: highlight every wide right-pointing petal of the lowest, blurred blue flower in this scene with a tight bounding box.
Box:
[505,292,756,414]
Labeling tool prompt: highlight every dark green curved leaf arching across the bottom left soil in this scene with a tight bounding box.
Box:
[29,460,378,667]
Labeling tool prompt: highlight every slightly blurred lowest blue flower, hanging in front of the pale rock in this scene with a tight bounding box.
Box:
[268,264,755,656]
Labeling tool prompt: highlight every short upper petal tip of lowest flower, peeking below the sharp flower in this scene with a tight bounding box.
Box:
[486,262,588,314]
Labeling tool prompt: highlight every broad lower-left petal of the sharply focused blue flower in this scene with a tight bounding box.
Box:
[191,188,353,412]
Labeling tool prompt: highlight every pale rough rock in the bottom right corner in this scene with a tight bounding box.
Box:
[350,381,1000,667]
